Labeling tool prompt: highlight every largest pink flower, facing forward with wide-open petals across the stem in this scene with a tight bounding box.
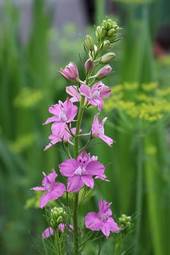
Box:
[59,151,106,192]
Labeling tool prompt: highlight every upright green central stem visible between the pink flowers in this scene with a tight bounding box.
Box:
[73,97,84,255]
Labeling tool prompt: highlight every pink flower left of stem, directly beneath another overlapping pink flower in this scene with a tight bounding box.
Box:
[44,123,76,150]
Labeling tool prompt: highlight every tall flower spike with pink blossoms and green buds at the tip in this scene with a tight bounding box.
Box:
[33,19,129,255]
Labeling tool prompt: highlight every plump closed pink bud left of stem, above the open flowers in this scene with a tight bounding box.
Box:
[60,62,79,81]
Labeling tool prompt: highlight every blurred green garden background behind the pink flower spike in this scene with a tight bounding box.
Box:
[0,0,170,255]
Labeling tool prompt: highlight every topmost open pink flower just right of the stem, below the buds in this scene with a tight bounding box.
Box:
[80,82,111,111]
